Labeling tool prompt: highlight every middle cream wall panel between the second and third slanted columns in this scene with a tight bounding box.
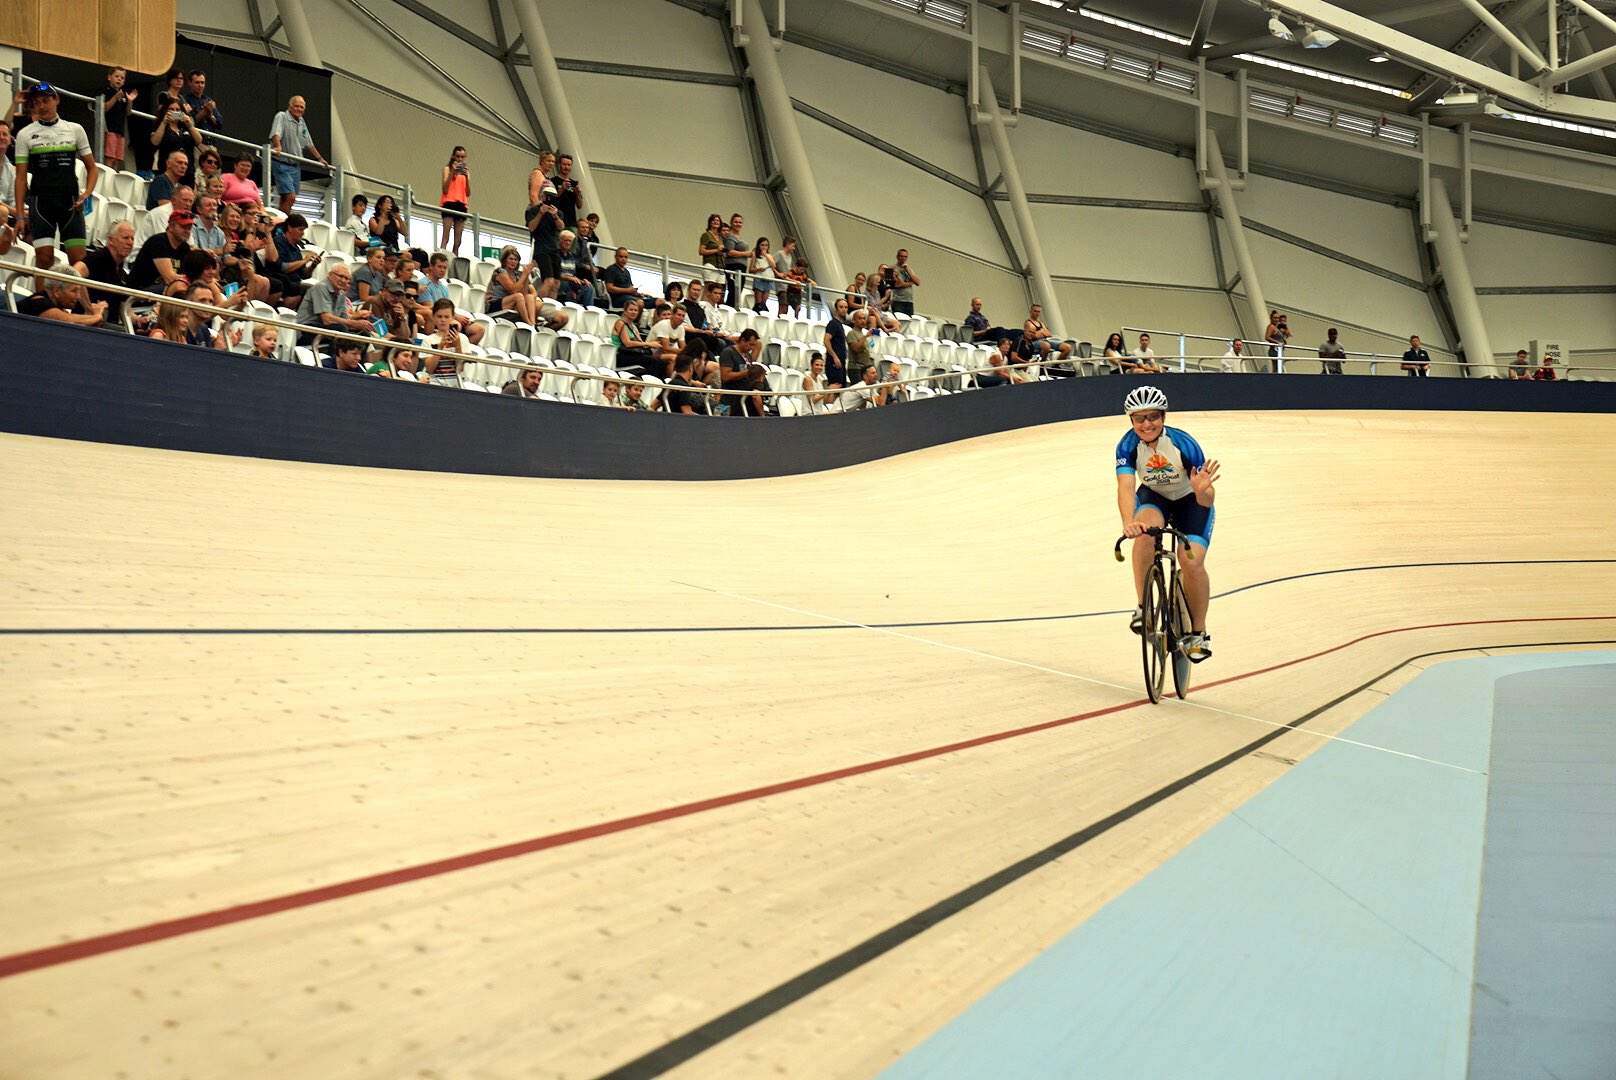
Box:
[561,73,755,181]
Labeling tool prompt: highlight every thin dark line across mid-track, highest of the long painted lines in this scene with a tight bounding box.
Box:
[0,559,1616,637]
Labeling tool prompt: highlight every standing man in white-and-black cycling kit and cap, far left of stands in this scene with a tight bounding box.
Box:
[13,82,95,278]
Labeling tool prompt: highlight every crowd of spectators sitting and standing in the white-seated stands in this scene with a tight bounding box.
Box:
[0,68,1583,409]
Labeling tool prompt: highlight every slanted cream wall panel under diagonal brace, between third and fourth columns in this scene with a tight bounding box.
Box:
[797,113,1005,265]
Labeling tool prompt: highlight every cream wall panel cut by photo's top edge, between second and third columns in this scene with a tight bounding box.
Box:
[523,0,730,74]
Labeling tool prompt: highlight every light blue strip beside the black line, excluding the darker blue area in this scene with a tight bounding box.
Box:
[882,653,1616,1080]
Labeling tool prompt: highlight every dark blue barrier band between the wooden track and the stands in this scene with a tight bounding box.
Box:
[0,314,1616,480]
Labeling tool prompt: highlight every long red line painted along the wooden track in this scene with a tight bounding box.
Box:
[0,614,1616,978]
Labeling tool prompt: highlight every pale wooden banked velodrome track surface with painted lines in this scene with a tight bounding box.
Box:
[0,412,1616,1080]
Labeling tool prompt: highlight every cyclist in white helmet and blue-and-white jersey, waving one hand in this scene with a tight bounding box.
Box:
[1117,386,1218,663]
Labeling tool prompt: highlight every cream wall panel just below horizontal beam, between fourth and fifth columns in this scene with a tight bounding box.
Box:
[1027,204,1217,286]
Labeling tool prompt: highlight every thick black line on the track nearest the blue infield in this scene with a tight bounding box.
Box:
[596,637,1616,1080]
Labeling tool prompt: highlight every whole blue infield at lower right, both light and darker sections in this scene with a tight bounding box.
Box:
[882,652,1616,1080]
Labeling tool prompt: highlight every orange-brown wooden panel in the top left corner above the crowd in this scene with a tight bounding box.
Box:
[0,0,176,73]
